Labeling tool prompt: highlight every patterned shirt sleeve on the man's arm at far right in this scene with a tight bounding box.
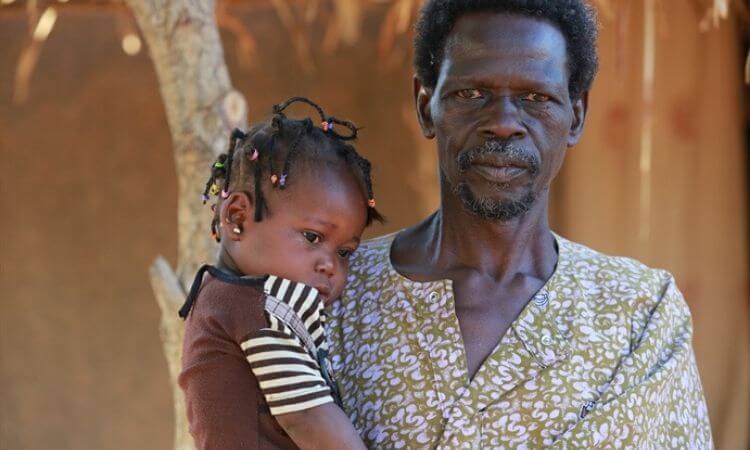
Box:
[556,276,713,449]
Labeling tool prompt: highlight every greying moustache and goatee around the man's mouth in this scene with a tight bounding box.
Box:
[454,141,540,222]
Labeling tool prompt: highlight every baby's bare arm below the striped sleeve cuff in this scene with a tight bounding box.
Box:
[276,403,366,450]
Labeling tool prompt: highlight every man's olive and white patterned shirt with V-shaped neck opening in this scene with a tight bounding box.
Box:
[328,235,713,449]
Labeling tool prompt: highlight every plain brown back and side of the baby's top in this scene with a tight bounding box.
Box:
[179,280,264,450]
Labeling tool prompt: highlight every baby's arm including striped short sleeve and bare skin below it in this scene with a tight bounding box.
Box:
[241,326,366,450]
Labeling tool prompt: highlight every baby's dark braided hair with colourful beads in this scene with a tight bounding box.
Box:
[202,97,384,242]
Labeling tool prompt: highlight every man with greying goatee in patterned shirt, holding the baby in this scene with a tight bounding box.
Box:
[330,0,712,449]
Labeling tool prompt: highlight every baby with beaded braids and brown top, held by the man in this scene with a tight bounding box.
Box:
[179,97,383,450]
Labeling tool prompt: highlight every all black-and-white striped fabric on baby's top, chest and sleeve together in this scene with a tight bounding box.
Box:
[241,275,333,415]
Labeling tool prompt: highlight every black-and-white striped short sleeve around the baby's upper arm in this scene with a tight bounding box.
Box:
[241,314,333,415]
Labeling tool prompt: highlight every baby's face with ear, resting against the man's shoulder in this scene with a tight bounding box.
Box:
[230,165,367,303]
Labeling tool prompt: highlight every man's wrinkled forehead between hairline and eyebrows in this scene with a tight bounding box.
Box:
[439,12,568,85]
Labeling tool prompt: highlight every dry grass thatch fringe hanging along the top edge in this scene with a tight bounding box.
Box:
[5,0,750,103]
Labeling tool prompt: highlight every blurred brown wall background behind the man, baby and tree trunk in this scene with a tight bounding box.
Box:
[0,0,750,450]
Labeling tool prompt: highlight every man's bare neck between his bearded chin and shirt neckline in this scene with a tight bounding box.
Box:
[391,188,557,283]
